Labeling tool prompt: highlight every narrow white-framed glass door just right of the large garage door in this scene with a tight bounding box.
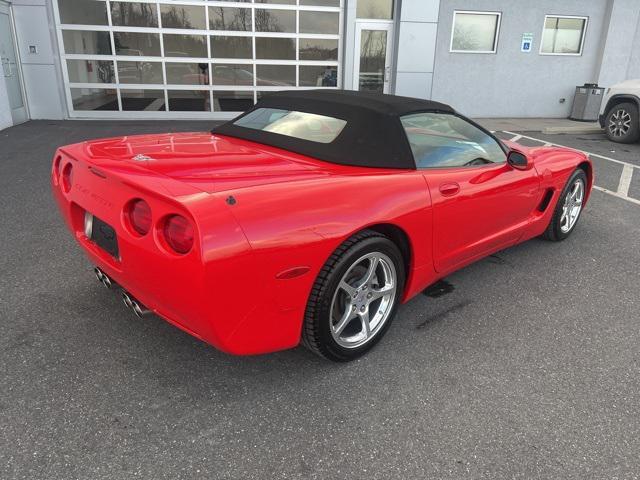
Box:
[353,22,393,93]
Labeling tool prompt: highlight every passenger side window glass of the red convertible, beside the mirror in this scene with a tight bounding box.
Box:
[401,113,506,168]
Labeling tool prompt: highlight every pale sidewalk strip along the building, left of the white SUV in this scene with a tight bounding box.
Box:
[474,118,602,134]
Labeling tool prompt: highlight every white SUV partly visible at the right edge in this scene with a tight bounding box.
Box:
[598,79,640,143]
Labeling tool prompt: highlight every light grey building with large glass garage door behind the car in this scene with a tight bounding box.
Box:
[0,0,640,128]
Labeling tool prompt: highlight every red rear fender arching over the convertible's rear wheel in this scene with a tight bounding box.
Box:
[220,171,432,350]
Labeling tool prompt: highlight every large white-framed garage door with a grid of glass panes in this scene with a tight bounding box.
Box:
[54,0,343,118]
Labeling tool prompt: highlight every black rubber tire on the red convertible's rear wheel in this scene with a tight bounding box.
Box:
[302,230,405,362]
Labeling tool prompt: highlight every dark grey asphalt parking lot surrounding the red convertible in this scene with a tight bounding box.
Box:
[0,121,640,479]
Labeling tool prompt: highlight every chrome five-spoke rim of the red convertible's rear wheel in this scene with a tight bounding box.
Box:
[330,252,398,348]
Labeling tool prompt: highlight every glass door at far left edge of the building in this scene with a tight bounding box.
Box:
[0,2,27,125]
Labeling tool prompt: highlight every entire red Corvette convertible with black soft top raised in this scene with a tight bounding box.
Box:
[51,90,593,361]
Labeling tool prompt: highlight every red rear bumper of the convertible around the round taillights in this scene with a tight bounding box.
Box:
[51,148,304,354]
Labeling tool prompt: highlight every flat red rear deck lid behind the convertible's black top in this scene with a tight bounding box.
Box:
[76,132,337,193]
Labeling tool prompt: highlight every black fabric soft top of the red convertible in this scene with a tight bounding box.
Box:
[211,90,454,169]
